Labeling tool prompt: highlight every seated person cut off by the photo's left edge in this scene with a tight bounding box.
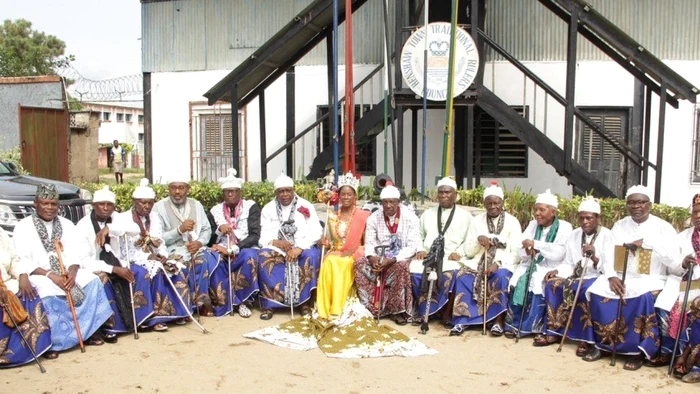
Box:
[0,228,51,368]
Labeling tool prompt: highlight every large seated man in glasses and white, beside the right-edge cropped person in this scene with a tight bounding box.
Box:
[584,186,683,370]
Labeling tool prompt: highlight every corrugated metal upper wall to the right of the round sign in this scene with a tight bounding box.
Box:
[486,0,700,61]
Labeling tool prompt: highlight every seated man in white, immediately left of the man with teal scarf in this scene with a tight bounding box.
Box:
[450,183,522,336]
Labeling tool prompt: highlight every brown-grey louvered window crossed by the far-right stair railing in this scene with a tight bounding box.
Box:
[574,107,630,195]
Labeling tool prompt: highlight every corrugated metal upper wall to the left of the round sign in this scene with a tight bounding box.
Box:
[141,0,395,72]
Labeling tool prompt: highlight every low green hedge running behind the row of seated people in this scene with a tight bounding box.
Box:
[81,181,690,231]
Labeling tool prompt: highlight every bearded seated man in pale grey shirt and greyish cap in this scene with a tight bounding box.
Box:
[153,175,217,316]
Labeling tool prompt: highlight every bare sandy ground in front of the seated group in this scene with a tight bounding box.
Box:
[0,311,700,393]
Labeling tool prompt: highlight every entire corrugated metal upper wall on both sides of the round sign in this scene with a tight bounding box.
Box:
[141,0,700,72]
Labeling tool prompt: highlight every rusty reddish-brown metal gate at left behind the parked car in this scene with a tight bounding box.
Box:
[19,106,68,182]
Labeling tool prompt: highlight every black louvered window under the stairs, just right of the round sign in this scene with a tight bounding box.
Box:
[474,107,528,178]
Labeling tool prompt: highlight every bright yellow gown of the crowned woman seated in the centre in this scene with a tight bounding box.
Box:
[316,211,362,319]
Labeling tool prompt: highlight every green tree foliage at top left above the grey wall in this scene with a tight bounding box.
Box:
[0,19,75,77]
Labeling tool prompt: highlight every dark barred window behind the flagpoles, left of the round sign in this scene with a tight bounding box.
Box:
[316,104,377,175]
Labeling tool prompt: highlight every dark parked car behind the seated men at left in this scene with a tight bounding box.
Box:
[0,162,92,235]
